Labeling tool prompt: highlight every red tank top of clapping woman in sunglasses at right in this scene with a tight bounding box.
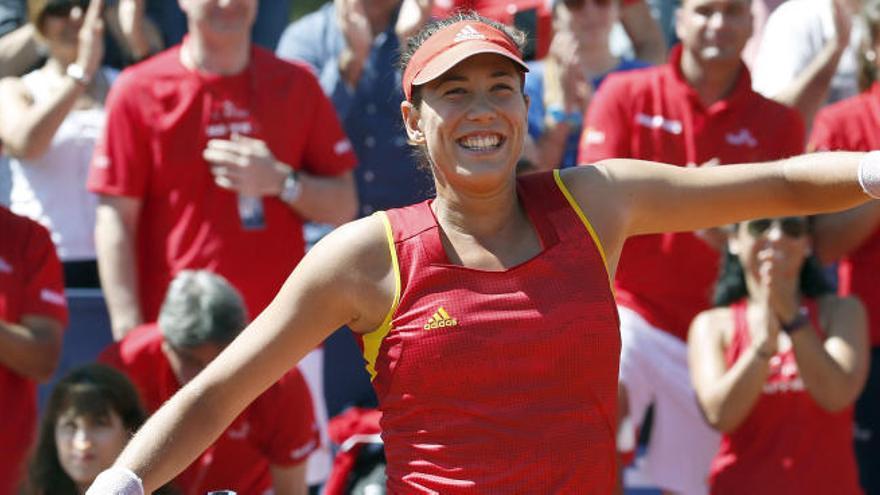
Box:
[709,301,862,495]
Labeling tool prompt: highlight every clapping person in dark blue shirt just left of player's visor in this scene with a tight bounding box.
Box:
[277,0,431,216]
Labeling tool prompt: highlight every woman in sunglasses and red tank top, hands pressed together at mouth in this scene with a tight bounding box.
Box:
[688,217,869,495]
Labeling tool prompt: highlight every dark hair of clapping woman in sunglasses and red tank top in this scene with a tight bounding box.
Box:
[713,225,833,306]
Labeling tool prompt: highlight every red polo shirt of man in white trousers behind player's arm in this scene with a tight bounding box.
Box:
[578,45,804,340]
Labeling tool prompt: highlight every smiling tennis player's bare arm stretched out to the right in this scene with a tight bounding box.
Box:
[561,152,880,274]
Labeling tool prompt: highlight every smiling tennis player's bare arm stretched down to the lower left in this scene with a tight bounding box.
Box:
[90,217,394,495]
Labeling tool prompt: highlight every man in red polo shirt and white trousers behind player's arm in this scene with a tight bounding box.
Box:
[579,0,804,493]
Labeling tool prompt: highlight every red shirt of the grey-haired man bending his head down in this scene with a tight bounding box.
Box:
[98,324,320,494]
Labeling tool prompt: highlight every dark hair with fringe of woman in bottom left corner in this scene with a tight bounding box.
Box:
[21,363,146,495]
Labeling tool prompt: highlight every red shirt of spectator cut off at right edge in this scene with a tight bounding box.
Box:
[809,84,880,347]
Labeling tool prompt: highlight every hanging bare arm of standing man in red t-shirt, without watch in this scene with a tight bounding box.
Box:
[95,196,143,341]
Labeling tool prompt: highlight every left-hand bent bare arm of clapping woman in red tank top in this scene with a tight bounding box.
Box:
[688,308,775,432]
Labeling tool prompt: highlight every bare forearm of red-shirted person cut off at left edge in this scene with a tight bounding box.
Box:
[0,315,62,381]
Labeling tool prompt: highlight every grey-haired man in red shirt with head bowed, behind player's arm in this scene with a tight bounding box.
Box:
[99,270,319,495]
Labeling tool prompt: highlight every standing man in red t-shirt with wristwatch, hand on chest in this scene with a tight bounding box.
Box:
[89,0,357,339]
